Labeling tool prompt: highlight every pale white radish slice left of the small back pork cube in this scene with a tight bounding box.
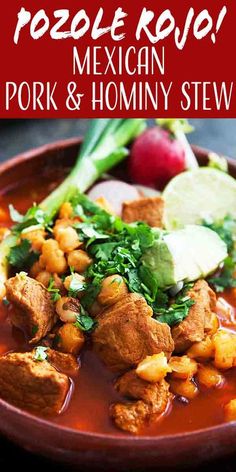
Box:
[88,180,140,216]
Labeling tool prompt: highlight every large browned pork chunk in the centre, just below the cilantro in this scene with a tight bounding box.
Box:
[93,293,174,371]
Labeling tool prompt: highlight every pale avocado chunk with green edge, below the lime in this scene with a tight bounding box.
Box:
[142,225,227,288]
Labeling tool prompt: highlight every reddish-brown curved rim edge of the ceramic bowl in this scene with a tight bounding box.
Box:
[0,137,236,448]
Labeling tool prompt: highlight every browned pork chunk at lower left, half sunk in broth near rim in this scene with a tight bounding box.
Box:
[0,352,70,415]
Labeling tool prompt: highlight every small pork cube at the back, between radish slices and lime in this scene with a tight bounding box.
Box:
[122,197,164,228]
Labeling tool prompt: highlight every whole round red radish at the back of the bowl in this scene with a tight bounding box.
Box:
[129,126,186,189]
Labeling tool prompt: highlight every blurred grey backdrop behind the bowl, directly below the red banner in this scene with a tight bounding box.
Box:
[0,119,236,161]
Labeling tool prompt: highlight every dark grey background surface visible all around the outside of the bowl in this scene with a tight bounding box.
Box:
[0,119,236,472]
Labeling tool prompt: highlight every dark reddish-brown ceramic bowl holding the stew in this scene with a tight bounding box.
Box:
[0,139,236,471]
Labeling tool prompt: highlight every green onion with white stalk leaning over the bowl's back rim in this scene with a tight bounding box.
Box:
[0,118,146,298]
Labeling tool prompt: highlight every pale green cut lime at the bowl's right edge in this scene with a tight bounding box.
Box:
[162,167,236,230]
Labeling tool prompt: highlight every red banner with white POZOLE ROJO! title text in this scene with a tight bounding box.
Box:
[0,0,236,118]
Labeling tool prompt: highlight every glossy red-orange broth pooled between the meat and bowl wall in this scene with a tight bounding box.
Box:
[0,178,236,436]
